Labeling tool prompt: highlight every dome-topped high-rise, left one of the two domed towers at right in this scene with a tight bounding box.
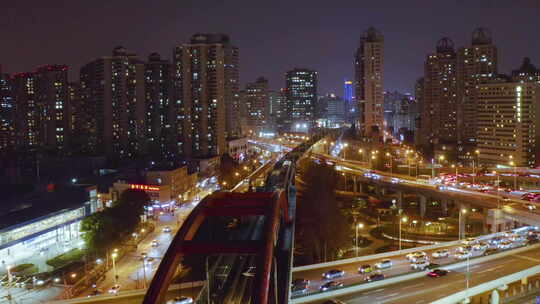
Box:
[421,38,457,144]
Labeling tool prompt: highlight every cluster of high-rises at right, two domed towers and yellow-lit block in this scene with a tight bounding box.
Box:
[415,28,540,167]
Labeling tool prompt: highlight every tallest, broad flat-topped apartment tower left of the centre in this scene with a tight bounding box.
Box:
[173,34,236,157]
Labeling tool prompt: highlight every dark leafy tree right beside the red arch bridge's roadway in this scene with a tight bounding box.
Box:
[296,161,350,264]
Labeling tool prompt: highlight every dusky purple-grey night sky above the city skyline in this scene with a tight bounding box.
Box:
[0,0,540,95]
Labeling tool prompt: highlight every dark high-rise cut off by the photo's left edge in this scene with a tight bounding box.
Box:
[0,65,15,153]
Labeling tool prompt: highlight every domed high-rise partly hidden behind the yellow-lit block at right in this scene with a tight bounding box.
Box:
[457,28,497,144]
